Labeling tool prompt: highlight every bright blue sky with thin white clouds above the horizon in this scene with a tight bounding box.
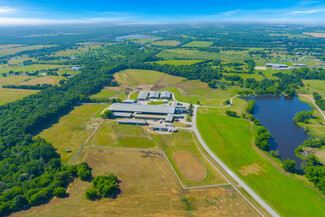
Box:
[0,0,325,25]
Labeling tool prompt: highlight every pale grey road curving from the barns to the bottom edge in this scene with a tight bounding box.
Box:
[192,105,280,217]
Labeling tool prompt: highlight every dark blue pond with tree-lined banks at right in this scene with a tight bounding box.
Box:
[244,96,313,166]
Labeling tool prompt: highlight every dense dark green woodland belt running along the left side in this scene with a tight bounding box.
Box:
[0,42,149,214]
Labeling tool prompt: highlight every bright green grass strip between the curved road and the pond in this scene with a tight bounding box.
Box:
[197,108,325,216]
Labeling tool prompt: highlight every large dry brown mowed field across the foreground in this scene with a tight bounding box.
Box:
[13,148,259,217]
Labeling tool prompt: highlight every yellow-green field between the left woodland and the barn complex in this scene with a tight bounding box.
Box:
[39,104,103,163]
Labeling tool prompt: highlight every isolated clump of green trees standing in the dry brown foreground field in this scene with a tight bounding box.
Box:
[85,174,119,200]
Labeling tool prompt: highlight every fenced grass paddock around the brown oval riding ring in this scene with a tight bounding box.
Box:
[151,130,227,187]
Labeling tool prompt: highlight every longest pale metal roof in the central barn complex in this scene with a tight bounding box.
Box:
[108,103,176,115]
